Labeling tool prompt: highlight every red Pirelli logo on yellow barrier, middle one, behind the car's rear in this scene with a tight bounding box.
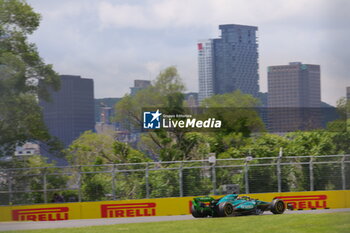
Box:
[101,202,156,218]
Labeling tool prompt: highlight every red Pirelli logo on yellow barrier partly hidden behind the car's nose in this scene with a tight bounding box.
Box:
[275,195,328,210]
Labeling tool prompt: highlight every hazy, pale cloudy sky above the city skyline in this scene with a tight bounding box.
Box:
[28,0,350,105]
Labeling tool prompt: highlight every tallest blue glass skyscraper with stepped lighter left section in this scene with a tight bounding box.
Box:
[198,24,259,100]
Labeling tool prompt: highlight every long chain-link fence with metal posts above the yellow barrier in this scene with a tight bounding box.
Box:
[0,155,350,205]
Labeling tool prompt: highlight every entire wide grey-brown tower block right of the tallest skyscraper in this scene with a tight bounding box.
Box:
[268,62,322,132]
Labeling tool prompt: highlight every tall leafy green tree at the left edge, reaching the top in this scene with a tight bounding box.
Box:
[0,0,60,156]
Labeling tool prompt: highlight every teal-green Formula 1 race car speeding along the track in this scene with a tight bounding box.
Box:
[191,194,293,218]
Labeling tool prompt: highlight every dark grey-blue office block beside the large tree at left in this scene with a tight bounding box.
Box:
[39,75,95,147]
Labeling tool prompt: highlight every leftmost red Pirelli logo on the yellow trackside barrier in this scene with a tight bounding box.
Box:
[12,207,69,221]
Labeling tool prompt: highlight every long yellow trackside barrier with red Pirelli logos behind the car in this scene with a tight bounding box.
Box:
[0,190,350,221]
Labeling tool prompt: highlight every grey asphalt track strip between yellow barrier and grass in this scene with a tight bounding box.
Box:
[0,208,350,231]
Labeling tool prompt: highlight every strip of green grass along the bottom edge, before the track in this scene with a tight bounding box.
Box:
[1,212,350,233]
